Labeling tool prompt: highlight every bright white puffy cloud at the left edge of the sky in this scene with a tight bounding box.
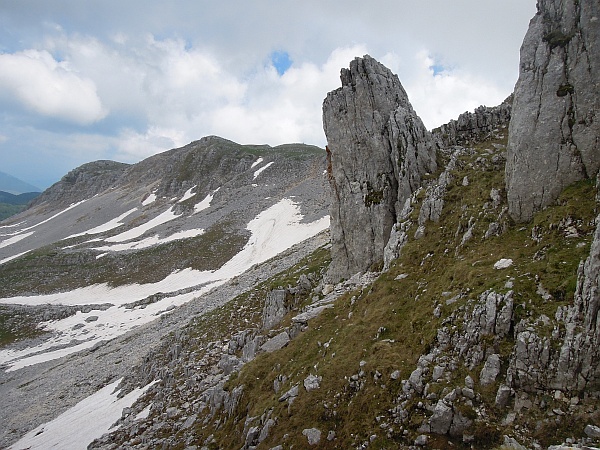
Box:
[0,50,108,125]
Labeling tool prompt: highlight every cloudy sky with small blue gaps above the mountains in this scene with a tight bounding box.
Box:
[0,0,536,189]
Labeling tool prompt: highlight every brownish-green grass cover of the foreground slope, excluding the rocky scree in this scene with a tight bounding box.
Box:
[186,132,595,449]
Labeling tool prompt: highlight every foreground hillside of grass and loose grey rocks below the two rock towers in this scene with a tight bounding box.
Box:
[86,124,600,449]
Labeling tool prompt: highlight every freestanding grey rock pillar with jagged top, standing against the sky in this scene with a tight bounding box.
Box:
[323,55,437,280]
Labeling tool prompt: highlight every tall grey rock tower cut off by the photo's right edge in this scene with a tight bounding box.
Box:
[506,0,600,221]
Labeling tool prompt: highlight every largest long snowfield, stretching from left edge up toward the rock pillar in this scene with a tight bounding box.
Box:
[0,198,329,371]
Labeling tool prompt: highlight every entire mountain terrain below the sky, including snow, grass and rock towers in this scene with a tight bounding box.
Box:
[0,0,600,450]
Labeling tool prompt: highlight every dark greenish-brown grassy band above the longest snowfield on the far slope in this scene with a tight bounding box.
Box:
[0,223,247,297]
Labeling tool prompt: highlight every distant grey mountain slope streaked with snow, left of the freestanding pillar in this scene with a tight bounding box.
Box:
[0,137,329,450]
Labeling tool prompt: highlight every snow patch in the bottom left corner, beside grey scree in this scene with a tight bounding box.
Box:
[8,378,155,450]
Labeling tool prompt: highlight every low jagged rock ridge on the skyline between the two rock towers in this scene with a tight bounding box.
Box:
[433,95,513,147]
